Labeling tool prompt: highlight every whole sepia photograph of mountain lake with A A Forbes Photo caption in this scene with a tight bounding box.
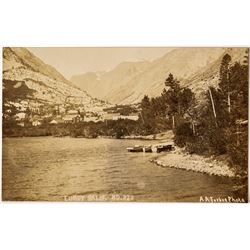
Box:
[2,47,249,203]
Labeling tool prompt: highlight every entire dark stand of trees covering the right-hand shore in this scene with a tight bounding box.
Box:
[139,50,248,174]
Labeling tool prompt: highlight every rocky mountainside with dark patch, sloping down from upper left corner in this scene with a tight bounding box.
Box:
[3,47,98,108]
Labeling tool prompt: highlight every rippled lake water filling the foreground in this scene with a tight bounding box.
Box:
[3,137,240,201]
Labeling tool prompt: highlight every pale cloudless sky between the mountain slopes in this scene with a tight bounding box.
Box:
[28,47,173,79]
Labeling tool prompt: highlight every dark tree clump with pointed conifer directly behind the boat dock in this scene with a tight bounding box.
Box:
[140,74,196,143]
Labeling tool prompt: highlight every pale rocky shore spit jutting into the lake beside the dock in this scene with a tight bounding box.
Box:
[152,148,236,177]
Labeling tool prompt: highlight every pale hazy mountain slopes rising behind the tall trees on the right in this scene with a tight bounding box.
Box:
[71,48,245,104]
